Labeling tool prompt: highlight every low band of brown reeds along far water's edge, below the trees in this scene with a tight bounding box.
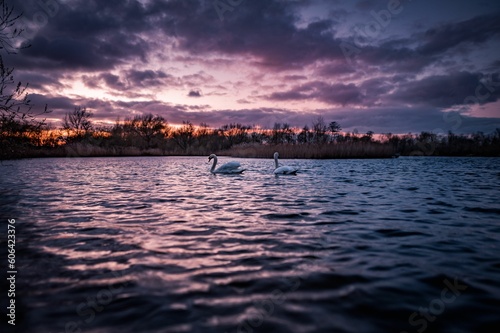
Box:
[0,137,500,161]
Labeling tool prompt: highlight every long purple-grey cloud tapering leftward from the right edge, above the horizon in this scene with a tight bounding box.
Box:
[267,68,500,108]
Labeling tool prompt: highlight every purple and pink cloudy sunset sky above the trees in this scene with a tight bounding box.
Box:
[3,0,500,134]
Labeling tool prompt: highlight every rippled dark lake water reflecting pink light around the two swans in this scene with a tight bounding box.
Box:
[0,156,500,333]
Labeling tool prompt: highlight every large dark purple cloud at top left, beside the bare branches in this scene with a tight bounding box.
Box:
[14,0,151,70]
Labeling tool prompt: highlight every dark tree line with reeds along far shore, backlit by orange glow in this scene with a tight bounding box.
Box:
[0,107,500,159]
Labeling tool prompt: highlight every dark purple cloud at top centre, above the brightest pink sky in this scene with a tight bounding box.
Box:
[146,0,343,69]
